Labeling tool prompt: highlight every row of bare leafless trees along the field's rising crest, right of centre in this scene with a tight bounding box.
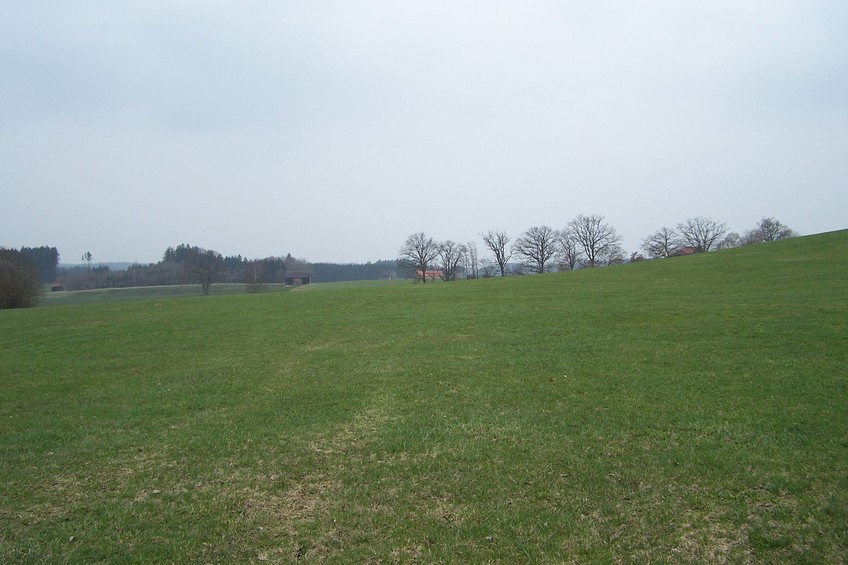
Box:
[398,214,796,282]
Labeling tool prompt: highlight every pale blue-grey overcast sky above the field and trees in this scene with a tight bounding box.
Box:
[0,0,848,263]
